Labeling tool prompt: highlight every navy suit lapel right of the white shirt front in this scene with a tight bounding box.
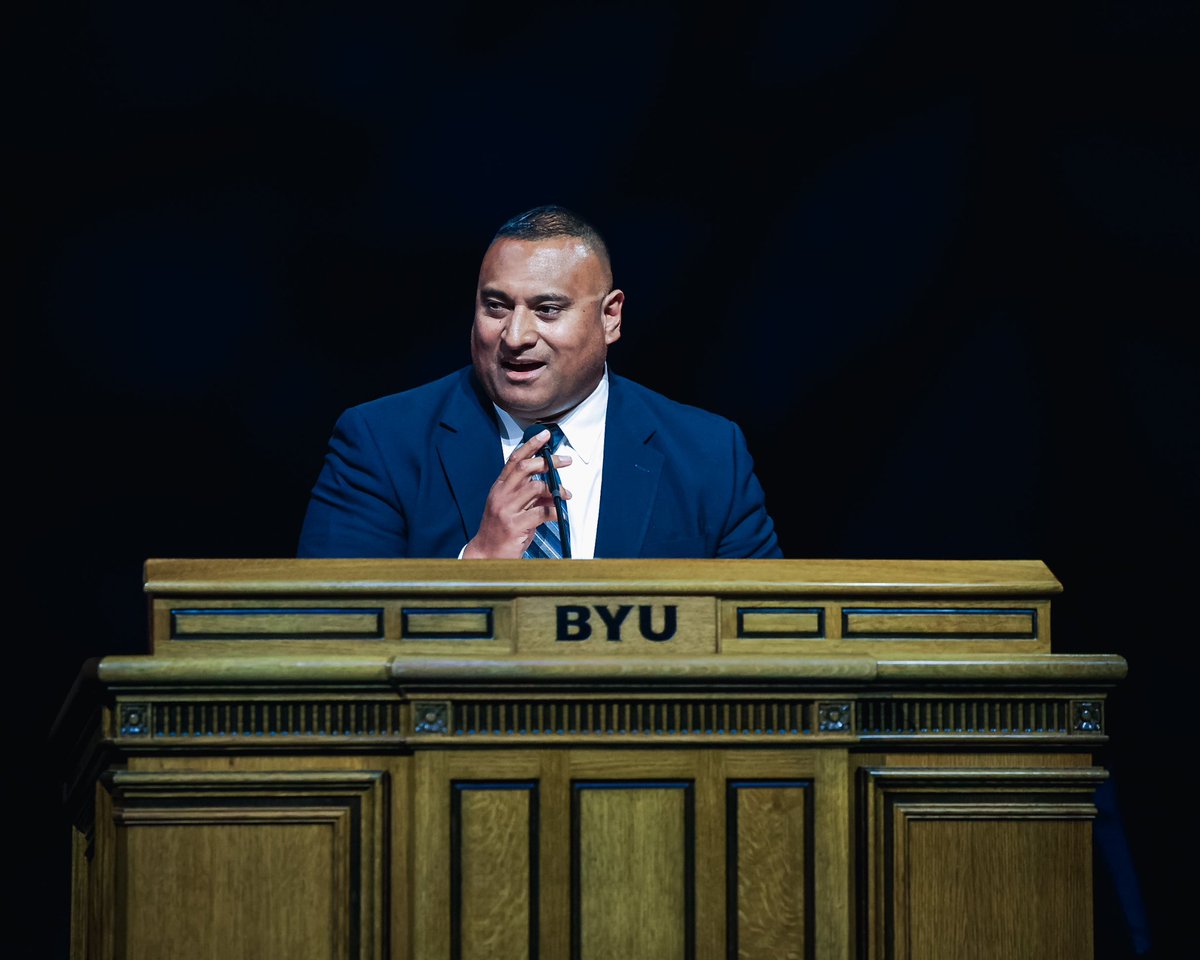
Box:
[595,374,662,557]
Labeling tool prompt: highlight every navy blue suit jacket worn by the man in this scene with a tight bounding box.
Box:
[298,367,781,557]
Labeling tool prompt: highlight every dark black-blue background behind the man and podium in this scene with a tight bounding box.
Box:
[5,0,1200,960]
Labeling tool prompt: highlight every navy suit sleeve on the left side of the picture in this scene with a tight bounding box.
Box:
[296,409,408,557]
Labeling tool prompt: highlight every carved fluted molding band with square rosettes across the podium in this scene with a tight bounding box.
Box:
[98,691,1105,750]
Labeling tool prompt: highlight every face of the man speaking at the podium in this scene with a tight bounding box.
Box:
[470,236,625,420]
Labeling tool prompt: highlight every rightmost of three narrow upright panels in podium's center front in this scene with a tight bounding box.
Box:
[726,780,812,960]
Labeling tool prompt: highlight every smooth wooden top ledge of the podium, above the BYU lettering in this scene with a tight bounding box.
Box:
[145,558,1062,598]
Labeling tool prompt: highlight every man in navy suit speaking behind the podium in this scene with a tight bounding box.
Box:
[298,206,781,559]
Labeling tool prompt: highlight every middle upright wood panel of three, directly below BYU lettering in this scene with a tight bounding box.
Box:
[571,781,695,960]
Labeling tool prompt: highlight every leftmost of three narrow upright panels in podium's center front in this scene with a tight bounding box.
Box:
[450,781,538,960]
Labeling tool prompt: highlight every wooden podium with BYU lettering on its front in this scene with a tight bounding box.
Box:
[55,560,1126,960]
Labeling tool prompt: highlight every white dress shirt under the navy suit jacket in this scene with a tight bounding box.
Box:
[489,367,608,560]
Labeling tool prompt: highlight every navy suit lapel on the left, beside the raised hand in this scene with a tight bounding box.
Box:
[434,371,504,542]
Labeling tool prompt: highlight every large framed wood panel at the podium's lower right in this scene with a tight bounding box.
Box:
[858,756,1104,960]
